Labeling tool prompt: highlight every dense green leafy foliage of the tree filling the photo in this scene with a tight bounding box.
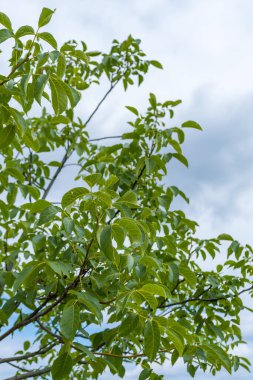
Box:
[0,8,252,380]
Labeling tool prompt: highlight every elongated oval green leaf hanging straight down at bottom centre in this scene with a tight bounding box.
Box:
[144,320,160,361]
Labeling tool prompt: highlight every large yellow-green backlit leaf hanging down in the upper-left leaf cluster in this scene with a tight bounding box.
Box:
[49,77,68,115]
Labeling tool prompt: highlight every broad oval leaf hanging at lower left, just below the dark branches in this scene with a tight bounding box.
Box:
[60,304,80,340]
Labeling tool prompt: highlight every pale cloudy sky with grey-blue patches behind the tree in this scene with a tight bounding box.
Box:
[0,0,253,380]
